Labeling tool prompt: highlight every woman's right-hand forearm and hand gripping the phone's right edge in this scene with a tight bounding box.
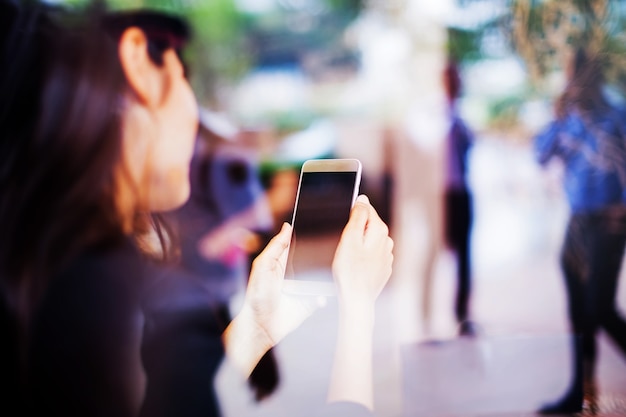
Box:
[328,196,393,410]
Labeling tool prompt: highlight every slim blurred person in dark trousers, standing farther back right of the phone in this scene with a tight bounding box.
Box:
[443,59,475,336]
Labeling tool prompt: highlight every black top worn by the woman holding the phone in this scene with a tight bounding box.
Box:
[0,242,370,417]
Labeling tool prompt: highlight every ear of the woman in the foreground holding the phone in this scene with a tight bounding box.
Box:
[118,27,167,107]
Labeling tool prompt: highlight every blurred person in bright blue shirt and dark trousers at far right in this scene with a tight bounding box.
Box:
[535,49,626,413]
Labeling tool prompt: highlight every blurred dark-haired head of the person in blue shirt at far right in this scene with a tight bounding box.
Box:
[555,48,609,118]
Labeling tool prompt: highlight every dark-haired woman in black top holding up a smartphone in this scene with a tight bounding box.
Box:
[0,0,393,417]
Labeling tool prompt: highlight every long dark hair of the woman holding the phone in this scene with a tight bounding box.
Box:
[0,0,189,328]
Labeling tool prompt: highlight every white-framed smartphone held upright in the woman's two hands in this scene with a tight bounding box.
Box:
[283,159,361,295]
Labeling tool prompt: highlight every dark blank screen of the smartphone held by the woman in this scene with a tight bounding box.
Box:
[286,172,357,281]
